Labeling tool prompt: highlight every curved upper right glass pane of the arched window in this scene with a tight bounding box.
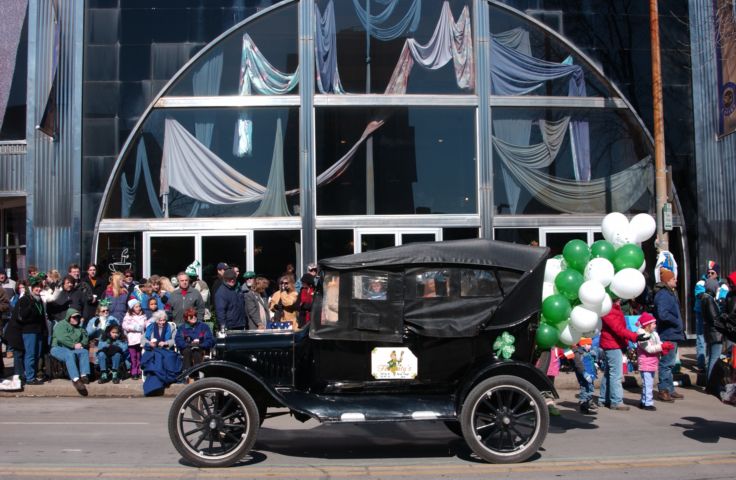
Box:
[490,5,618,97]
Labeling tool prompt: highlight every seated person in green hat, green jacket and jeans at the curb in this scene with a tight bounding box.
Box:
[51,308,89,396]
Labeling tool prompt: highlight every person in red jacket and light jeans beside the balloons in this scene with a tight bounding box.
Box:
[598,300,649,410]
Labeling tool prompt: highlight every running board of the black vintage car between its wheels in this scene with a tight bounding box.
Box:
[282,391,457,423]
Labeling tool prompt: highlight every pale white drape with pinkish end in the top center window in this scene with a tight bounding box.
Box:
[385,2,475,95]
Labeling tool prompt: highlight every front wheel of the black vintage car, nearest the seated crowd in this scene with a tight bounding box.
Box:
[169,378,260,467]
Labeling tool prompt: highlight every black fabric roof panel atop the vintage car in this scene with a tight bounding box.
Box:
[320,239,549,271]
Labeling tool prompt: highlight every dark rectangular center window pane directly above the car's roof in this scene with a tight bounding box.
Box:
[316,107,477,215]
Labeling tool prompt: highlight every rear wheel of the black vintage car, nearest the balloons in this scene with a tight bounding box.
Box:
[460,375,549,463]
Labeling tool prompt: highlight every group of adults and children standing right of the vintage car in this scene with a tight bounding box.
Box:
[538,261,736,415]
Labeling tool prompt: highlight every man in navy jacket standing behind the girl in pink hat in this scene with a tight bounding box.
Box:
[654,268,685,402]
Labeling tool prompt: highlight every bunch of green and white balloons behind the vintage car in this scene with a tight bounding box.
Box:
[536,212,657,349]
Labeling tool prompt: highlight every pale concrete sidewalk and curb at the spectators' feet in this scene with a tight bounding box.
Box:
[0,344,705,398]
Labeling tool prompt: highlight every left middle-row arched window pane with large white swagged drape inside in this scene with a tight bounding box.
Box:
[105,108,299,218]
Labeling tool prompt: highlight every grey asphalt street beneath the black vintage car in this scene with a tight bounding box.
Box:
[0,389,736,480]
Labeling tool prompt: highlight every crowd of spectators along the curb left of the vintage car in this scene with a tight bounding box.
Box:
[0,262,317,395]
